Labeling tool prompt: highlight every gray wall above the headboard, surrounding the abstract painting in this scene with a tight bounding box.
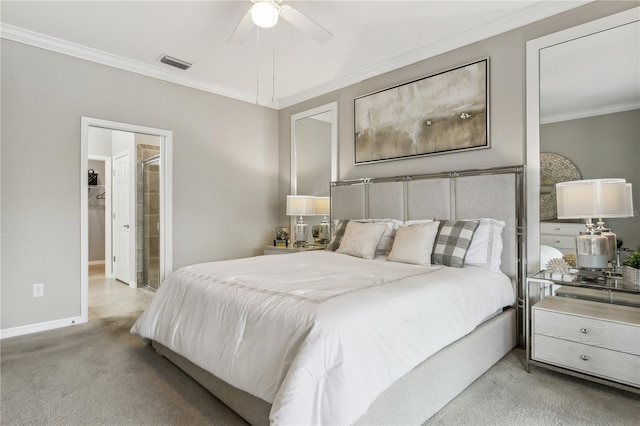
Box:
[280,2,637,223]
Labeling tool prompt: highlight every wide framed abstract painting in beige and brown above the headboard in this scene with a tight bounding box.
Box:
[354,58,490,165]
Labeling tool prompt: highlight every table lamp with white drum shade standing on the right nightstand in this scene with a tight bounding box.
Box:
[556,179,630,270]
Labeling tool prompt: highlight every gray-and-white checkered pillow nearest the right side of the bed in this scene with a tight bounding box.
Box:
[431,220,479,268]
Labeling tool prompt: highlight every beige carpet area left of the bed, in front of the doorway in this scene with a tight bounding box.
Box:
[0,317,244,425]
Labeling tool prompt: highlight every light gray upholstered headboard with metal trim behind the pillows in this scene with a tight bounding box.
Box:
[331,166,526,340]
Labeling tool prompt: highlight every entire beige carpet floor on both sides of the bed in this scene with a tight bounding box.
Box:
[0,272,640,425]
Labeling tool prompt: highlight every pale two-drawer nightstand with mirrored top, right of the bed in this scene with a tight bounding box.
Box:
[525,272,640,393]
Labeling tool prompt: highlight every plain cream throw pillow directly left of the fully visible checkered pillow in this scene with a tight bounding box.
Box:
[389,221,440,266]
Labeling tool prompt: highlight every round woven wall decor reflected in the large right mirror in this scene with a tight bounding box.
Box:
[540,152,581,220]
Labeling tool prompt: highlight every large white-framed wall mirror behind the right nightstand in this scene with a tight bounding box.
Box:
[527,8,640,273]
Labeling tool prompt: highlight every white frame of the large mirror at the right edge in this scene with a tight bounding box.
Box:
[526,7,640,275]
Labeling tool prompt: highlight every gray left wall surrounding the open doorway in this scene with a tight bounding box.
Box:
[0,39,279,330]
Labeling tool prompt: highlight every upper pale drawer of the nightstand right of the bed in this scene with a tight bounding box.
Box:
[533,309,640,355]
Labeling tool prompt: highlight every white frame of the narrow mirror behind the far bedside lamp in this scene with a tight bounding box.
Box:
[289,102,338,235]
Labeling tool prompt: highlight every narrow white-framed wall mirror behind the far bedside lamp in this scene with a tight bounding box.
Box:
[290,102,338,243]
